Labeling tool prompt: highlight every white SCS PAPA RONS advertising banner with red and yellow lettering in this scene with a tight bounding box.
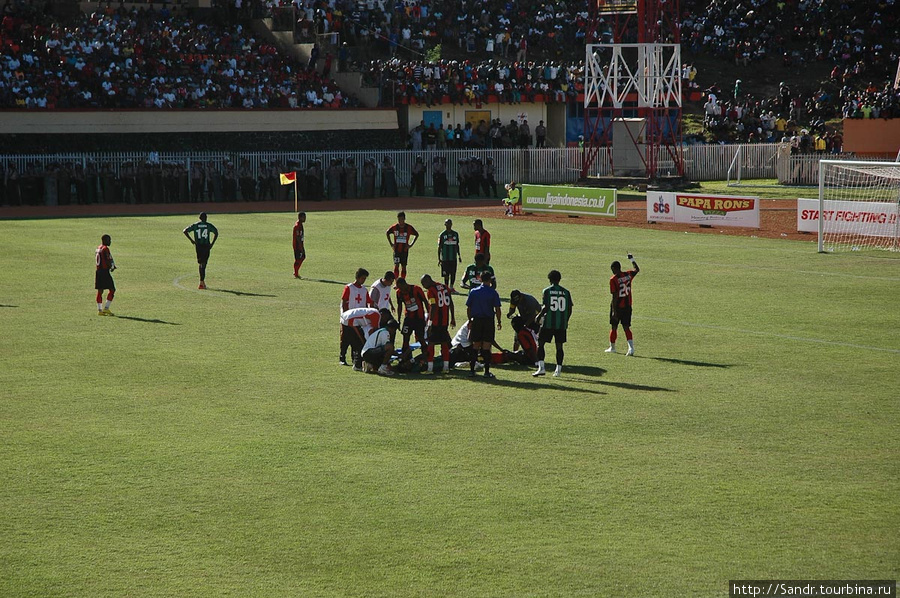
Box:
[647,191,759,228]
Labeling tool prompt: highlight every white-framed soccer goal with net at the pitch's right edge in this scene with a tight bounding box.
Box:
[819,160,900,252]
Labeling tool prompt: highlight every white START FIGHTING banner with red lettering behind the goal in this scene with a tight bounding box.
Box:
[797,197,900,237]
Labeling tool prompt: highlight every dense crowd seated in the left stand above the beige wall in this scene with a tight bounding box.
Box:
[0,4,357,109]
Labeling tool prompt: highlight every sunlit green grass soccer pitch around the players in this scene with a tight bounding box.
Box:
[0,211,900,598]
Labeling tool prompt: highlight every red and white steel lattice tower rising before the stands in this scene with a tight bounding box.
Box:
[581,0,684,180]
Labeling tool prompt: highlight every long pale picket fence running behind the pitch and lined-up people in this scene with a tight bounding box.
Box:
[0,144,800,205]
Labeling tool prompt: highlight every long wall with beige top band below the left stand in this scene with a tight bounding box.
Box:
[0,109,402,153]
